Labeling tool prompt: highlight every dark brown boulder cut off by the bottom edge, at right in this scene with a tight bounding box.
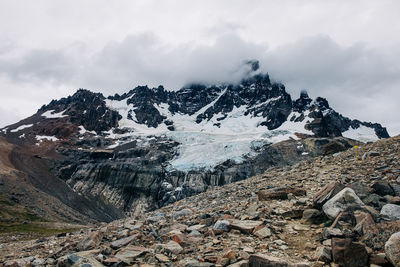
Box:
[332,238,368,267]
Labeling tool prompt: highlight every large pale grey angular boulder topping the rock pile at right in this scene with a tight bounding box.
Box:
[322,187,365,219]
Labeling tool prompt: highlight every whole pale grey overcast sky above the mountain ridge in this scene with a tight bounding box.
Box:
[0,0,400,135]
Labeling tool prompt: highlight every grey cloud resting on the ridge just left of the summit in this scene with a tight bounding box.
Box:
[84,34,265,91]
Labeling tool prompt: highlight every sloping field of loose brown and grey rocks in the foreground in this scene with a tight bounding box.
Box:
[0,136,400,267]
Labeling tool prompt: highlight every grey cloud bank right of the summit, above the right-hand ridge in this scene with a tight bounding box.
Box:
[262,35,400,135]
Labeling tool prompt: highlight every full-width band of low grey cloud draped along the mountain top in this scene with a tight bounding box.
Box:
[0,32,400,134]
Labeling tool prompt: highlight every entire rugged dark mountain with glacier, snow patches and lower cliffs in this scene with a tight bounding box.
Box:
[0,61,389,222]
